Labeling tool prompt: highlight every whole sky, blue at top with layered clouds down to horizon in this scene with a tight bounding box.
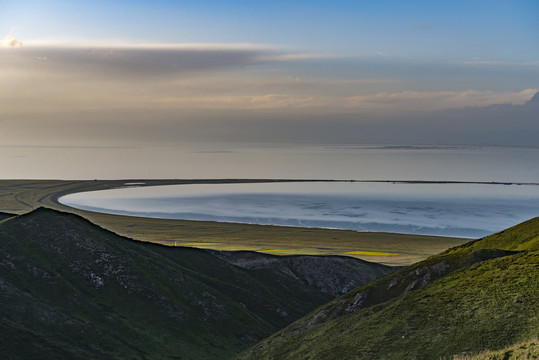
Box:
[0,0,539,177]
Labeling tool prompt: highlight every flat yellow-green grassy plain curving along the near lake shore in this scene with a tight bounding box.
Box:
[0,180,469,265]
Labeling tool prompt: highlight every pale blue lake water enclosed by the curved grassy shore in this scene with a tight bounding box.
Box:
[60,182,539,238]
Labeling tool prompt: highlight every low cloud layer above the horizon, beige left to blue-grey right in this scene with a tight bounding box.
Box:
[0,89,539,146]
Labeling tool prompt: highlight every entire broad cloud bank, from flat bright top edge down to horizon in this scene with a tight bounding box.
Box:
[0,38,539,146]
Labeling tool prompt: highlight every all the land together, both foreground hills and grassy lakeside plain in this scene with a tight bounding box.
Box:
[0,180,539,360]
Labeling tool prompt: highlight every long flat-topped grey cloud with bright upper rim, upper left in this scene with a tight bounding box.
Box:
[0,42,272,79]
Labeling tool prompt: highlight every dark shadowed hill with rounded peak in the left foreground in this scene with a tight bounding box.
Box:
[0,208,393,359]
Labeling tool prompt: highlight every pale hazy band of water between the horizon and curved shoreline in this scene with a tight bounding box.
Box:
[0,143,539,182]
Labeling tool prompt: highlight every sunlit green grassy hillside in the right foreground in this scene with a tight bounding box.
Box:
[238,218,539,360]
